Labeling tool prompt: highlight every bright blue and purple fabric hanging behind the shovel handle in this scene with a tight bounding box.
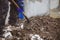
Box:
[17,0,24,19]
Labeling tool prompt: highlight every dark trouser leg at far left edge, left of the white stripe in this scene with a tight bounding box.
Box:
[0,0,8,35]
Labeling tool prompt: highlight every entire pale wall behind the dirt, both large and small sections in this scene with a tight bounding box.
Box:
[25,0,59,18]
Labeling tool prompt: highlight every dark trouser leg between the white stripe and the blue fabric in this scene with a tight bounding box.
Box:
[9,1,18,25]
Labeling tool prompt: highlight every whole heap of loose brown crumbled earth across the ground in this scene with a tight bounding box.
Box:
[2,16,60,40]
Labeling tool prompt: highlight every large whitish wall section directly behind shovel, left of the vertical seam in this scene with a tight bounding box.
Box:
[25,0,49,17]
